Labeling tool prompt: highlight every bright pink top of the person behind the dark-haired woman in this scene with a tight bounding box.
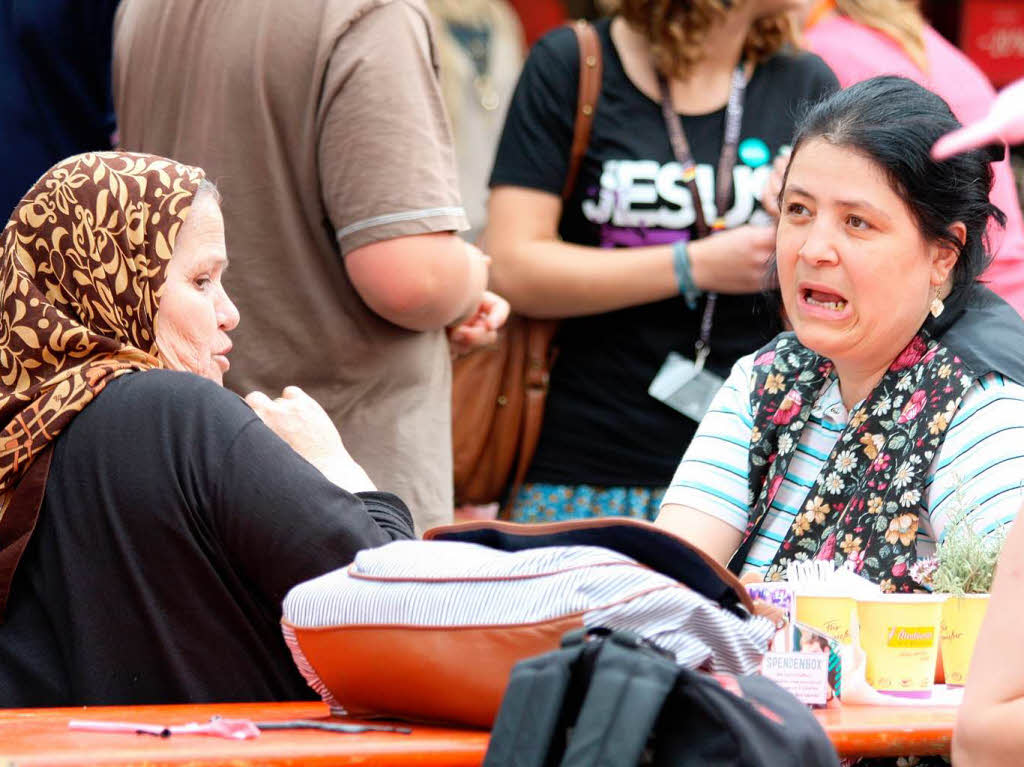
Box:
[804,15,1024,315]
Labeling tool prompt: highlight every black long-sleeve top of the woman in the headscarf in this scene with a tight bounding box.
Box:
[0,371,413,707]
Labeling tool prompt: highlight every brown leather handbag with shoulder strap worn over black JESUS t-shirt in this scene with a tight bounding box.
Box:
[452,20,601,514]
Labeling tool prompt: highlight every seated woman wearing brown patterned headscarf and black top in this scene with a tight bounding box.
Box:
[0,153,413,707]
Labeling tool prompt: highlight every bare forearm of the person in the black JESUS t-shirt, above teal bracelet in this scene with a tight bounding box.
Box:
[490,240,679,317]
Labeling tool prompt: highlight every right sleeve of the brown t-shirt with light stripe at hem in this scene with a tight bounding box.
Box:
[317,0,468,254]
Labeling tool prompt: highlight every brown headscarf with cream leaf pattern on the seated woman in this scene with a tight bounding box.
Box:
[0,152,204,619]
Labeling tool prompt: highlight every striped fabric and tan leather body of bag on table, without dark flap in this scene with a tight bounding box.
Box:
[283,541,774,726]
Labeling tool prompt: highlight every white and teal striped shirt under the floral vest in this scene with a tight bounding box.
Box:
[662,354,1024,572]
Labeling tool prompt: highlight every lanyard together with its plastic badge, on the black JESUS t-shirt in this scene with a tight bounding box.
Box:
[647,61,746,422]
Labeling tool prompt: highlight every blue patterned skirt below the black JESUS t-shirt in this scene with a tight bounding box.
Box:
[511,482,666,522]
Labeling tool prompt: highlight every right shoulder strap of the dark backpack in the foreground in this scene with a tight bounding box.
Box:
[561,632,679,767]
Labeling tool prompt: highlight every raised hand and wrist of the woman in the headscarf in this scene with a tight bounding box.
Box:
[246,386,377,493]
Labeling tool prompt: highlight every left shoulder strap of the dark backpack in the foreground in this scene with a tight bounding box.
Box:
[483,632,586,767]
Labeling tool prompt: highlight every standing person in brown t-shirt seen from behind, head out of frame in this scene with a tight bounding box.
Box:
[114,0,508,531]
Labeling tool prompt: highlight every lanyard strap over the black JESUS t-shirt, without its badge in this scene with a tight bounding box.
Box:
[657,61,746,368]
